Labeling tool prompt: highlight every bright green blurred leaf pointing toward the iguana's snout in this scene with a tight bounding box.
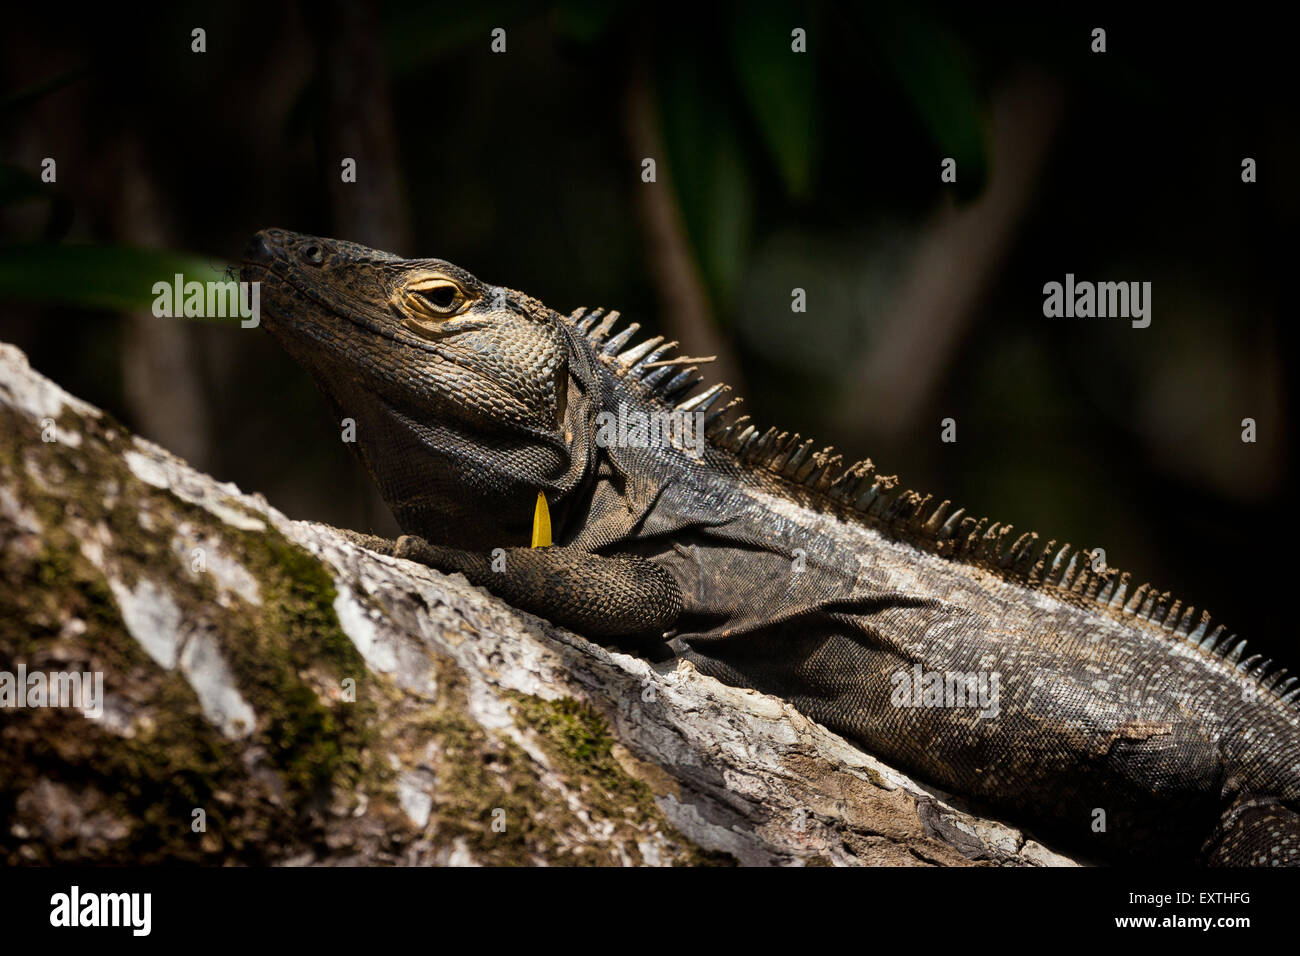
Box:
[0,245,237,321]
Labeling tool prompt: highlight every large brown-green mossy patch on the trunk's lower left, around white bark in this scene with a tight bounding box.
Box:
[0,400,391,862]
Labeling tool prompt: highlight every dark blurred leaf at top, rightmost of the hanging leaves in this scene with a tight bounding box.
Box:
[867,7,988,198]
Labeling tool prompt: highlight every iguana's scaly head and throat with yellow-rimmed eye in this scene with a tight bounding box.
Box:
[241,229,586,548]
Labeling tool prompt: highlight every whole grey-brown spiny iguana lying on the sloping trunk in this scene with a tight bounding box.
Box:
[243,230,1300,864]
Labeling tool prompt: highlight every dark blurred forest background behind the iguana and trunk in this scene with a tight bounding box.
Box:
[0,0,1300,665]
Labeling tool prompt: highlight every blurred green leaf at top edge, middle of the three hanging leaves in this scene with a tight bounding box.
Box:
[728,3,818,196]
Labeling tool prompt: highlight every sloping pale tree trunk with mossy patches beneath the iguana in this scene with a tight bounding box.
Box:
[0,345,1070,865]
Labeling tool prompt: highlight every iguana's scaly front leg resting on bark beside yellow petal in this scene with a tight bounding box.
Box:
[391,535,681,637]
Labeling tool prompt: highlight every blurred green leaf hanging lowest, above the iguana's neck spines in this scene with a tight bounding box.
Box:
[660,44,754,312]
